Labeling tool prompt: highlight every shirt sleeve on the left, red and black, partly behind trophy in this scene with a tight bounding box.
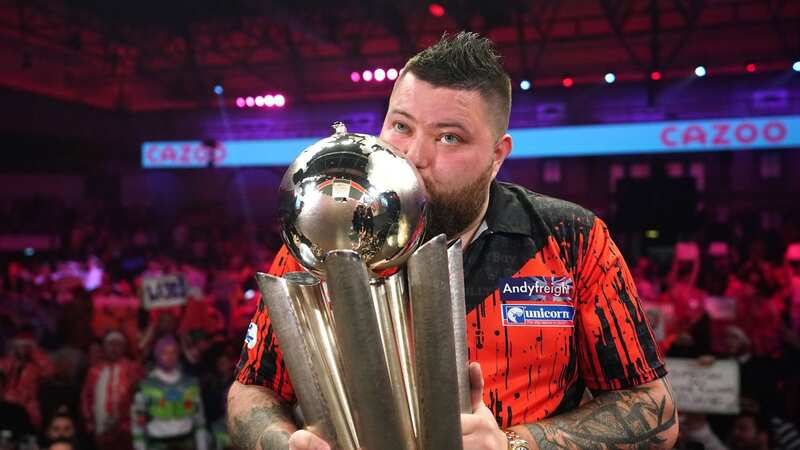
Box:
[236,246,302,402]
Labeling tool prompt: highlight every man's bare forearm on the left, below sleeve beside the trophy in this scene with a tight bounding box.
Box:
[228,384,295,450]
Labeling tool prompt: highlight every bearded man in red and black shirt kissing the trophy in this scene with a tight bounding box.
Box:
[228,33,678,450]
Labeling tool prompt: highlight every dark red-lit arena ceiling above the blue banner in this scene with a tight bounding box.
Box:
[0,0,800,111]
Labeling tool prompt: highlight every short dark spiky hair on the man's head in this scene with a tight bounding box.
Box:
[403,31,511,135]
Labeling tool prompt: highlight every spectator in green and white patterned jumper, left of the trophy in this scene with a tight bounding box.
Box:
[131,336,208,450]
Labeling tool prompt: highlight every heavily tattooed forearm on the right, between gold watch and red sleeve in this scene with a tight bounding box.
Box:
[526,378,677,450]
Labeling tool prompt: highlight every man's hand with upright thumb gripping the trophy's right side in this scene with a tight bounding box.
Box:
[461,362,508,450]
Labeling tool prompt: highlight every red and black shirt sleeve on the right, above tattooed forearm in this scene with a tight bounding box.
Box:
[575,218,667,390]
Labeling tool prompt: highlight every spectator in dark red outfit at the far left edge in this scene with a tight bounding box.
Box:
[0,329,53,427]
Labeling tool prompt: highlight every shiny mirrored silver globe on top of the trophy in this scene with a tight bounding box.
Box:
[278,122,428,278]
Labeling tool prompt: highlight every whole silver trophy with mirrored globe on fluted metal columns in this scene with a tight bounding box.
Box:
[256,122,471,450]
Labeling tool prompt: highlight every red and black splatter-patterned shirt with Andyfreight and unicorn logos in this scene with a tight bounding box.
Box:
[237,183,666,427]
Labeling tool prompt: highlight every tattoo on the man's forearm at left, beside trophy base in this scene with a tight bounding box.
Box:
[231,403,291,450]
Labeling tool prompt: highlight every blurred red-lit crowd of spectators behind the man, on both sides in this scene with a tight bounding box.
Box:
[0,200,800,450]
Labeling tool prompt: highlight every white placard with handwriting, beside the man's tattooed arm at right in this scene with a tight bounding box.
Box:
[667,358,740,414]
